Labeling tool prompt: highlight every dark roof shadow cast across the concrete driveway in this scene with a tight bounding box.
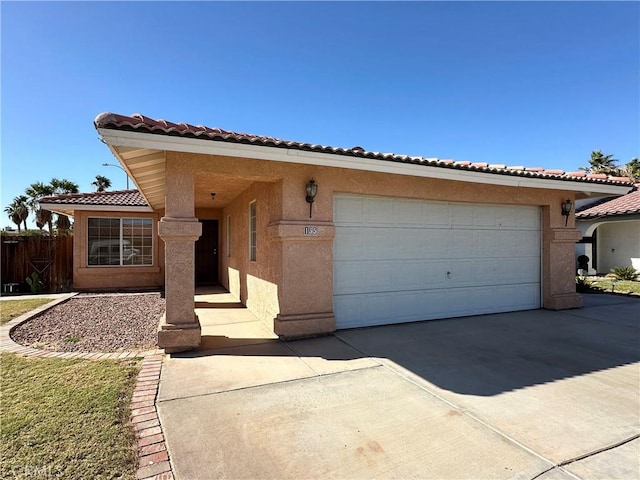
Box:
[174,295,640,396]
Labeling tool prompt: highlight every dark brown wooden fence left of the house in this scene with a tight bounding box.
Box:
[0,236,73,293]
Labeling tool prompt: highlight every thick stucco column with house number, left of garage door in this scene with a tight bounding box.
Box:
[268,220,336,338]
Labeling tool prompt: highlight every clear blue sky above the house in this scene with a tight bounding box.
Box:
[0,1,640,226]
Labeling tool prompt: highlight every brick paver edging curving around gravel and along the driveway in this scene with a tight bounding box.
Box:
[0,292,174,480]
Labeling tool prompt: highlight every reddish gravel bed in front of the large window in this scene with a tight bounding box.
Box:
[11,293,165,352]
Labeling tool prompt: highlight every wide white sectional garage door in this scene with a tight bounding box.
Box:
[333,195,541,328]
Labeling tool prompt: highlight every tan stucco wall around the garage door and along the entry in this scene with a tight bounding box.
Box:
[167,152,581,336]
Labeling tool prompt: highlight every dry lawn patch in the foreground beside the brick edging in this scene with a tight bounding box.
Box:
[0,353,140,479]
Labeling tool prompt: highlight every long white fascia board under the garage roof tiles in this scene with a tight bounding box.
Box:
[98,128,631,195]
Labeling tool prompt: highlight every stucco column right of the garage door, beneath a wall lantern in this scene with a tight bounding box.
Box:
[543,228,582,310]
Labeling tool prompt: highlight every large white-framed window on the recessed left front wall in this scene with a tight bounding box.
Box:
[87,217,153,266]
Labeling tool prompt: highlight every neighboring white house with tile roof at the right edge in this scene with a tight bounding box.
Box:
[576,185,640,275]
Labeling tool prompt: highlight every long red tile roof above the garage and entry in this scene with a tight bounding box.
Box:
[94,112,631,186]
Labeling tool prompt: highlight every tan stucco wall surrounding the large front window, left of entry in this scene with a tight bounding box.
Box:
[73,211,164,290]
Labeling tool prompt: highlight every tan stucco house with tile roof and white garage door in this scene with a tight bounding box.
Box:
[41,113,632,352]
